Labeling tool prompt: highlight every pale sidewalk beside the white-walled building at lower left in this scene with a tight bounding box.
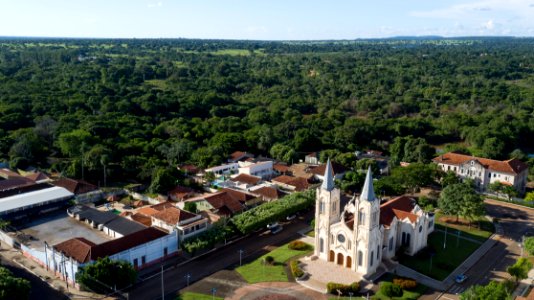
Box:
[0,243,110,299]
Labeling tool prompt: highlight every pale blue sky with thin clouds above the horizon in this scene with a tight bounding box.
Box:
[0,0,534,40]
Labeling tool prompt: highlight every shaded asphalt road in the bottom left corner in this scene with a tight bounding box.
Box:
[2,253,69,300]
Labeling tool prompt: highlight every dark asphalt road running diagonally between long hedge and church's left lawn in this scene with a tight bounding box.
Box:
[128,219,309,300]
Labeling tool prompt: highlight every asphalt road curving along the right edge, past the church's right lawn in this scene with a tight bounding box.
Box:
[439,200,534,300]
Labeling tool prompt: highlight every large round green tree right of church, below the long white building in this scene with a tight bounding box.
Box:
[438,183,484,221]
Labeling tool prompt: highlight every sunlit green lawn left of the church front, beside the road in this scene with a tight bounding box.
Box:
[236,244,312,283]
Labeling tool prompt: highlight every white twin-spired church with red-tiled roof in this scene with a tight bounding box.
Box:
[314,160,434,277]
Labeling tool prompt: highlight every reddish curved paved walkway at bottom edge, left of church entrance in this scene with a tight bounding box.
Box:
[225,282,328,300]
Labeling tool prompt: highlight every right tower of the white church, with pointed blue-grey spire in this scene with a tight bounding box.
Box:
[354,167,382,275]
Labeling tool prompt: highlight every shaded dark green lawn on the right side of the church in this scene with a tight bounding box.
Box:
[399,231,480,280]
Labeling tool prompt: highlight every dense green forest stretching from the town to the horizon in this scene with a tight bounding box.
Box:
[0,38,534,182]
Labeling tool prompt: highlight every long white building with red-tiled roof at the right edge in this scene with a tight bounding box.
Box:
[433,152,528,193]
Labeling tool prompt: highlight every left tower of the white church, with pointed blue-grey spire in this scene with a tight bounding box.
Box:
[315,159,340,260]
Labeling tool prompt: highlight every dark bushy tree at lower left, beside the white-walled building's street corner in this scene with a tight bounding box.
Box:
[76,257,137,293]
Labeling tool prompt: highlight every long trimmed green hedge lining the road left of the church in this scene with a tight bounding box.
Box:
[231,190,315,234]
